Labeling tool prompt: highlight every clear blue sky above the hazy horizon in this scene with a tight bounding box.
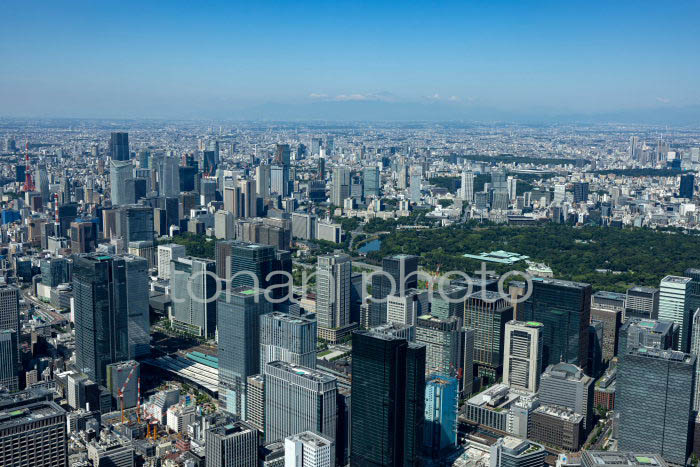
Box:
[0,0,700,118]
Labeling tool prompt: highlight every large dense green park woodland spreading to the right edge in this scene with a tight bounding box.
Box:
[368,222,700,292]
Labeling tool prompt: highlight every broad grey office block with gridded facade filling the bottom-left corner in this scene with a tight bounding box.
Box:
[0,401,68,467]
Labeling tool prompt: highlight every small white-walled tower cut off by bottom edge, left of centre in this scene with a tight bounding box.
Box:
[205,422,258,467]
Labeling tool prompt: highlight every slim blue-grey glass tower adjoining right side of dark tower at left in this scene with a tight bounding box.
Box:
[124,255,151,359]
